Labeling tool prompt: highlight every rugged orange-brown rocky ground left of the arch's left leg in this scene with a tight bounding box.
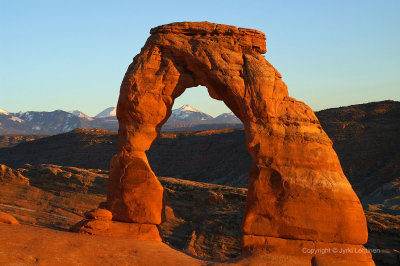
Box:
[0,165,108,230]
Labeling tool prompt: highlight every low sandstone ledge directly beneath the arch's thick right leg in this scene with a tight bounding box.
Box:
[241,235,375,266]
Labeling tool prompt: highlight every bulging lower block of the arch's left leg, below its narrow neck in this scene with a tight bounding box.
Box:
[106,151,164,224]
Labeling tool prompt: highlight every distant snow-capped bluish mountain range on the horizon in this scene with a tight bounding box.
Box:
[0,105,242,135]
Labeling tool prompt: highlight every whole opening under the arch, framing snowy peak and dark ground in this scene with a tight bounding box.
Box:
[146,87,252,260]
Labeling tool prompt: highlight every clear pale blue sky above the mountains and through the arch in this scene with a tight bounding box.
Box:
[0,0,400,115]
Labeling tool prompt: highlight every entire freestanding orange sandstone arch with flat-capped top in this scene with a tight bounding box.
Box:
[107,22,368,260]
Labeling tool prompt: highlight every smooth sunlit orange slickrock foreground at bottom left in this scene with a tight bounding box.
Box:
[0,224,202,266]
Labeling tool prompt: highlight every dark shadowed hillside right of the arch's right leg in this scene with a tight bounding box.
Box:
[316,101,400,197]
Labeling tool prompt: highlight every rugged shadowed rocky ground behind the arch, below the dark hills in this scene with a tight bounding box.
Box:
[0,165,400,265]
